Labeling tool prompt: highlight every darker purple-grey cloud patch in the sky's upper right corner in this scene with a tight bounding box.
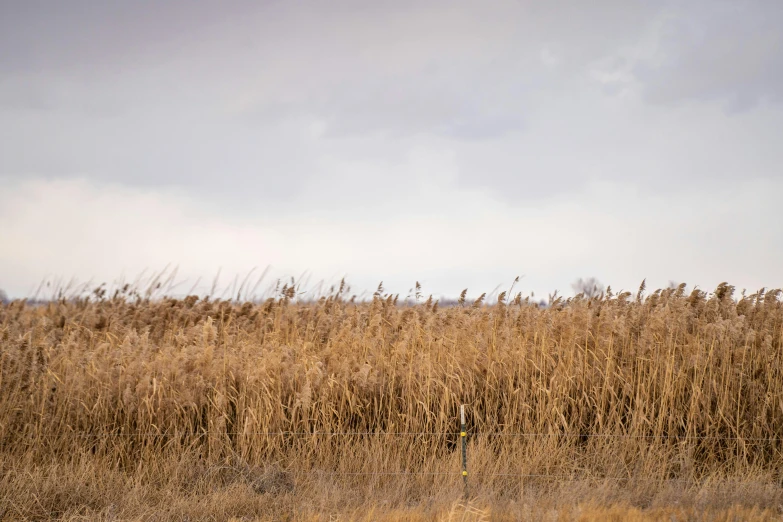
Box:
[634,0,783,109]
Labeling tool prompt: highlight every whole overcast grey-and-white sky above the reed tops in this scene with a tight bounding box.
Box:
[0,0,783,296]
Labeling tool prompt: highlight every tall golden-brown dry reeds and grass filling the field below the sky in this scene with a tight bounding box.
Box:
[0,285,783,520]
